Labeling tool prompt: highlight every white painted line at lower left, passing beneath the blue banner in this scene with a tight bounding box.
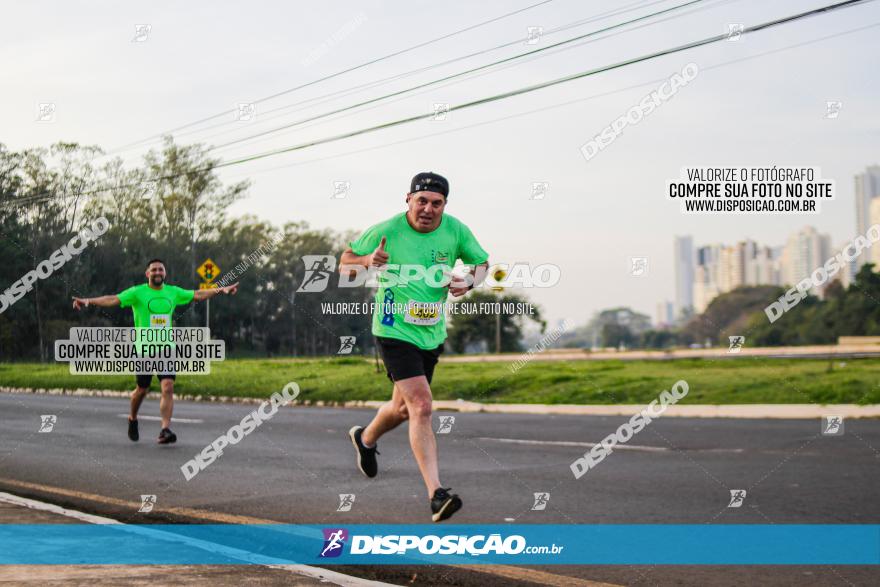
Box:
[0,492,393,587]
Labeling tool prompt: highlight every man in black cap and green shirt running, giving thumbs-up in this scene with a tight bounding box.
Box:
[339,172,489,522]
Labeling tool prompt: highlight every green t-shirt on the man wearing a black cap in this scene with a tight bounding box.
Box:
[350,213,489,350]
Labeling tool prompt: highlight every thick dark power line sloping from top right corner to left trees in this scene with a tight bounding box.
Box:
[5,0,872,210]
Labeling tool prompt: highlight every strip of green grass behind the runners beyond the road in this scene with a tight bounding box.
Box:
[0,357,880,404]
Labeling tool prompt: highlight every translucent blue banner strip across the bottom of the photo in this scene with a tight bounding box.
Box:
[0,524,880,565]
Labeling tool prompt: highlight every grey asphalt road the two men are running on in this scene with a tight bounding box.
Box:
[0,394,880,585]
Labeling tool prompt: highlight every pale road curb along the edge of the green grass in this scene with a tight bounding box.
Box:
[0,386,880,420]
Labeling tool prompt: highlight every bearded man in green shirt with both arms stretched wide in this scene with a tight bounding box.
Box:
[73,259,238,444]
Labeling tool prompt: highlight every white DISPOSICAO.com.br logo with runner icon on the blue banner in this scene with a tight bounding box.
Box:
[318,528,565,558]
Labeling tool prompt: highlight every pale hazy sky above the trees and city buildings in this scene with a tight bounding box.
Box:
[0,0,880,324]
